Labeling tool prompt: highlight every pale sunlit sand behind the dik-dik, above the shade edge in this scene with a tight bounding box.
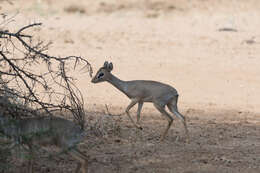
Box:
[0,0,260,112]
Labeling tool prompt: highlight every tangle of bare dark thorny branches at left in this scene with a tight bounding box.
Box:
[0,16,92,128]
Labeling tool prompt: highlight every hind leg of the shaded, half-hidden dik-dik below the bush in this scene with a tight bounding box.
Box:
[68,148,88,173]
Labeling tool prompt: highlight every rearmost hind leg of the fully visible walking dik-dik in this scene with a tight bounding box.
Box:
[167,96,190,142]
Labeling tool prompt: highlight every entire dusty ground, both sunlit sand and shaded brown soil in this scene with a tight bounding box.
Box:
[0,0,260,173]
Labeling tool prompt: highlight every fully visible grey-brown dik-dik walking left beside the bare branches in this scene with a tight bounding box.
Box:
[91,61,189,141]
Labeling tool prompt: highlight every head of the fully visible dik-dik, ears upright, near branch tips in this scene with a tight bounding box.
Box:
[91,61,113,83]
